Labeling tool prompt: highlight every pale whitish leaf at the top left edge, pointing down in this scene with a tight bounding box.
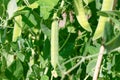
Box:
[7,0,17,19]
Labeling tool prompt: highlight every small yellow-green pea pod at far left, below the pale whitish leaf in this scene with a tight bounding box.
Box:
[12,15,22,42]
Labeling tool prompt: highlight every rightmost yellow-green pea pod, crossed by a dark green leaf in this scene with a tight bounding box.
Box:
[93,0,114,40]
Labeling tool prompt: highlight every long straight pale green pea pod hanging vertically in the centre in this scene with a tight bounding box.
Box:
[51,13,59,69]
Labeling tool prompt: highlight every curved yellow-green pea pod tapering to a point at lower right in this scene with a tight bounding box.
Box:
[74,0,92,32]
